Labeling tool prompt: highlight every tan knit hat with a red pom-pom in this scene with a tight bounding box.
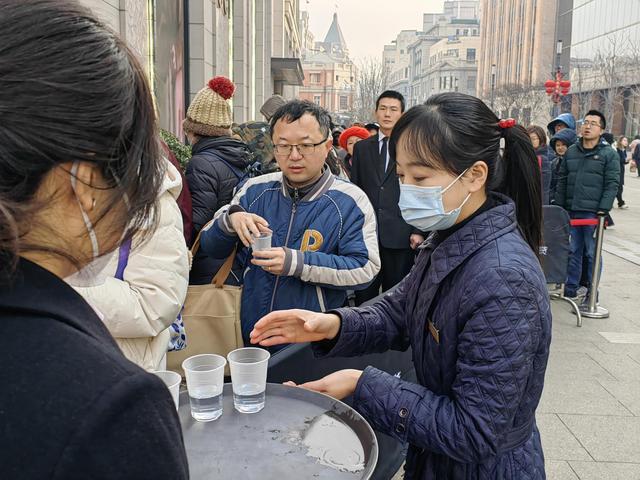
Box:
[182,77,236,137]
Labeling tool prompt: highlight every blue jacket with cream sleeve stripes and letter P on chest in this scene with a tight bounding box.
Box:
[200,168,380,342]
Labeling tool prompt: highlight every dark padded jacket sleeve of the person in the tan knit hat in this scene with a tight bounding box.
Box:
[185,155,220,233]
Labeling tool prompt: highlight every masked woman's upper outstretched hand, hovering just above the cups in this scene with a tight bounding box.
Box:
[249,310,340,347]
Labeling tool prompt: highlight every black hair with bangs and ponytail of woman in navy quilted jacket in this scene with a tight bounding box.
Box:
[390,93,542,255]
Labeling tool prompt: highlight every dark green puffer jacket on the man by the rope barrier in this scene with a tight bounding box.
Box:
[556,139,620,213]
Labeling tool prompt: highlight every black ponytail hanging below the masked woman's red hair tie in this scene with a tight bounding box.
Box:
[496,125,542,255]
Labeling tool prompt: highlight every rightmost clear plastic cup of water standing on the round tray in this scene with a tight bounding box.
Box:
[227,347,271,413]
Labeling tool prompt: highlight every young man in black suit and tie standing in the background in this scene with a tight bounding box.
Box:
[351,90,424,305]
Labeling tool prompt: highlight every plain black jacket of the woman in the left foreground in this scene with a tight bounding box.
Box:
[0,260,189,480]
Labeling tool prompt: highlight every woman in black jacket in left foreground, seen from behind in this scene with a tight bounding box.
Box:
[0,0,188,479]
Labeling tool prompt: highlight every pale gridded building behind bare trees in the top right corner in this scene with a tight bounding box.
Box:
[559,0,640,135]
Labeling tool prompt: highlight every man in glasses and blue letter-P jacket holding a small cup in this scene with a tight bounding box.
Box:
[201,100,380,343]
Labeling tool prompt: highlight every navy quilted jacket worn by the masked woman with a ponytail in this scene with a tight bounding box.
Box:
[314,194,551,480]
